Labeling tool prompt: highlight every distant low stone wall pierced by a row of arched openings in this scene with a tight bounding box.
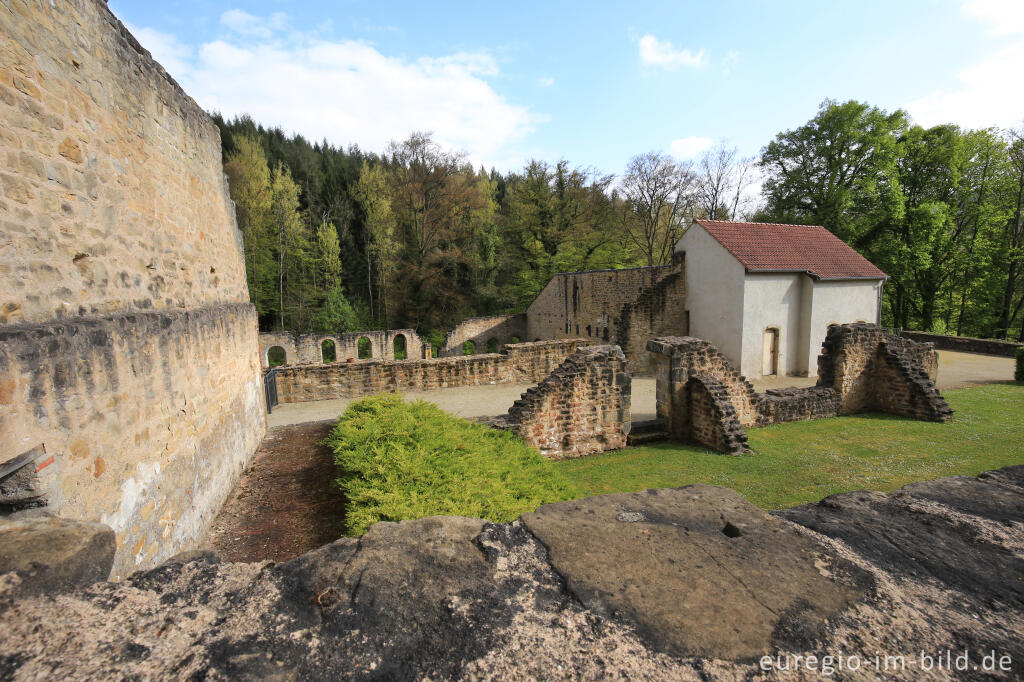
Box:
[259,329,429,369]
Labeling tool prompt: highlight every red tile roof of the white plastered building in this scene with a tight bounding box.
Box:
[693,219,886,280]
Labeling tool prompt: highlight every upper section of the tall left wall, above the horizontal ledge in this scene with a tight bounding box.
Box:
[0,0,248,324]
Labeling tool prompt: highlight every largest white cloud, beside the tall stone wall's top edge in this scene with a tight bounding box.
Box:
[124,10,545,167]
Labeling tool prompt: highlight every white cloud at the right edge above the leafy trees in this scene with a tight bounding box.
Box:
[906,41,1024,128]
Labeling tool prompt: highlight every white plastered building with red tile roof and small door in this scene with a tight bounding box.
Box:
[676,220,886,379]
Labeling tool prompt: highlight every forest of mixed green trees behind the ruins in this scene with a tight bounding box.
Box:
[214,100,1024,344]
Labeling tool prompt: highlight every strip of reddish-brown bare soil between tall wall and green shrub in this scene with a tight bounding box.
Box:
[204,422,345,561]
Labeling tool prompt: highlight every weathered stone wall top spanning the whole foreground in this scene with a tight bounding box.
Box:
[0,467,1024,680]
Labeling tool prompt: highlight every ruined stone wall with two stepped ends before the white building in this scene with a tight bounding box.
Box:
[647,324,952,453]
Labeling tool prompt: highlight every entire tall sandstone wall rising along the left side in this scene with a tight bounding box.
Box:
[0,0,265,576]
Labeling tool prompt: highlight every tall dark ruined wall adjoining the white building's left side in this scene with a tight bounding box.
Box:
[526,255,688,373]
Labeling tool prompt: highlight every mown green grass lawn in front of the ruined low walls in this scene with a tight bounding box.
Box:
[557,383,1024,509]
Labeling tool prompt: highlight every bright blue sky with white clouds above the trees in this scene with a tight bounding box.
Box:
[110,0,1024,173]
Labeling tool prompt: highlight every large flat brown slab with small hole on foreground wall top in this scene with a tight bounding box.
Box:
[523,485,871,660]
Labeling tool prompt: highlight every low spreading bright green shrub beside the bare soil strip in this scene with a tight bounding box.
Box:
[325,394,577,536]
